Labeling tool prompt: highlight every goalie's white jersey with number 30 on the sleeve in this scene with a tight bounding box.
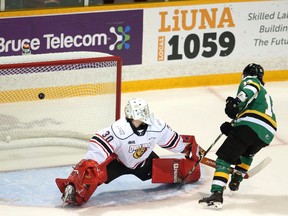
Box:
[84,118,187,169]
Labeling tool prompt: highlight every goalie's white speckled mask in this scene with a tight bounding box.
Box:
[124,98,151,124]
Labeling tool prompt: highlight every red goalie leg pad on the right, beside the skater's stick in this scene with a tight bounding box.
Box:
[152,158,201,183]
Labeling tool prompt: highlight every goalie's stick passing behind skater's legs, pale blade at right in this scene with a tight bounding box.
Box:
[201,157,272,179]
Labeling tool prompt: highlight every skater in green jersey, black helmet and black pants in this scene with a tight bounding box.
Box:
[199,63,277,209]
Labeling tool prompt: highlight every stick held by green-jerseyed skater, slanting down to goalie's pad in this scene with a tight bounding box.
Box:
[179,93,258,188]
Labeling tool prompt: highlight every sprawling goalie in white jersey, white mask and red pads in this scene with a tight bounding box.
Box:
[56,98,200,206]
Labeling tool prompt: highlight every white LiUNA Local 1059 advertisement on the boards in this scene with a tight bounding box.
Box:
[144,1,288,73]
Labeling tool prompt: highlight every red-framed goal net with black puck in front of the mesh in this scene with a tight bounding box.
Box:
[0,52,121,150]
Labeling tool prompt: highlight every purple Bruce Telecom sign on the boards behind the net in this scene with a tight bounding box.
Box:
[0,10,143,65]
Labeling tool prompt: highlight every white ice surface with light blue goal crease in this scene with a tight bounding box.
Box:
[0,81,288,216]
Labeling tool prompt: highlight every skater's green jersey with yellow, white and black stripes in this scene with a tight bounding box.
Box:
[234,76,277,144]
